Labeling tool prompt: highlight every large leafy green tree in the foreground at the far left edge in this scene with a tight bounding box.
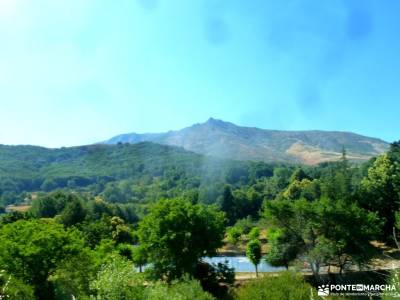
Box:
[0,220,84,299]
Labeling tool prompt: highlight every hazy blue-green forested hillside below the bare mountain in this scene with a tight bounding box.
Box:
[0,142,262,198]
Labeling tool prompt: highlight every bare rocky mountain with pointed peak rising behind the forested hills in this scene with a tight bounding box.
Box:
[103,118,389,165]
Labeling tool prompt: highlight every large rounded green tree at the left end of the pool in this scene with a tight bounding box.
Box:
[138,199,225,280]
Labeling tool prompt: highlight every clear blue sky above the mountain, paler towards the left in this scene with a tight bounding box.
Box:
[0,0,400,147]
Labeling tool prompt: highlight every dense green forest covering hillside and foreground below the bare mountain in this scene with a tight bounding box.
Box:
[0,143,400,299]
